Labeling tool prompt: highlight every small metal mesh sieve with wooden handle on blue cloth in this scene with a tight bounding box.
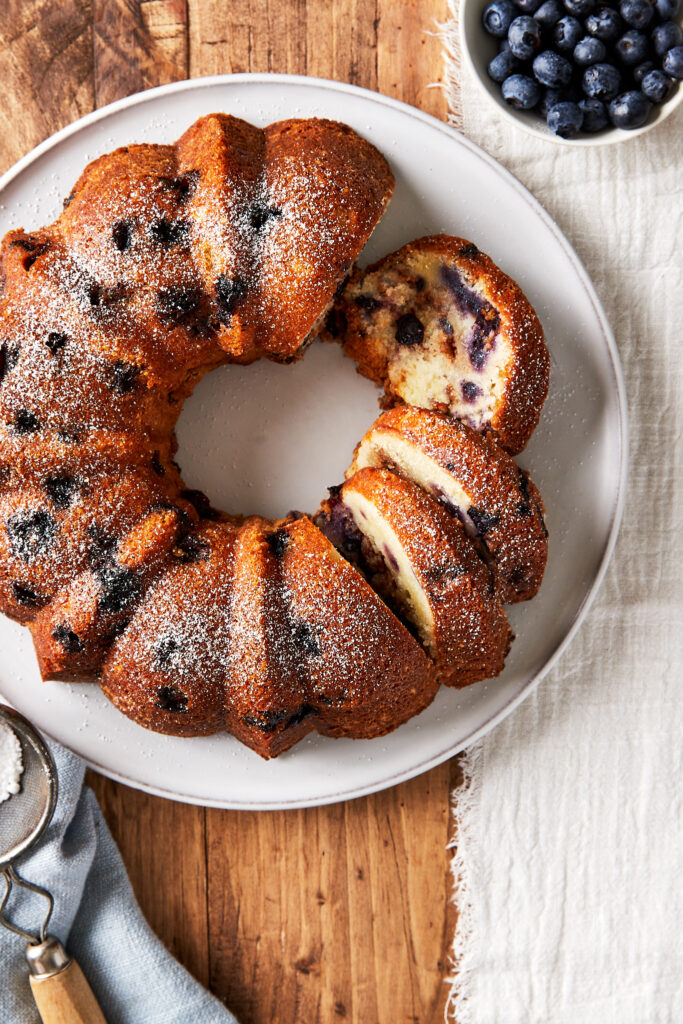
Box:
[0,703,105,1024]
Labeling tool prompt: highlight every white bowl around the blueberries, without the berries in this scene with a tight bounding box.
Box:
[460,0,683,145]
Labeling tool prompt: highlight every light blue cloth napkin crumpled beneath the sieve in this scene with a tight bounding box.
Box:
[0,743,237,1024]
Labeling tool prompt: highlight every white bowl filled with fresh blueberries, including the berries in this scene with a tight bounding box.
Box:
[461,0,683,145]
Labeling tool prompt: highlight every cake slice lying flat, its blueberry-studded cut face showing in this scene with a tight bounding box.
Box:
[328,234,550,454]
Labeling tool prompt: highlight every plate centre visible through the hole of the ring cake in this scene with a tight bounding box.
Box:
[177,343,380,518]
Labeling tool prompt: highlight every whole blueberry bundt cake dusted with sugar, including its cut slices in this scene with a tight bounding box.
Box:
[0,115,547,758]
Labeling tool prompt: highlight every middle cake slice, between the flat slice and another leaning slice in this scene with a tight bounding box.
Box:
[346,406,548,602]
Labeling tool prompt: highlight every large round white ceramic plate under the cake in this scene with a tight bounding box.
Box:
[0,75,627,809]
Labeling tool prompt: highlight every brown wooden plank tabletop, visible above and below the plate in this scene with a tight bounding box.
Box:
[0,0,458,1024]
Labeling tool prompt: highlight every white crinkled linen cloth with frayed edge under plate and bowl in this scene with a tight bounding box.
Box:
[444,0,683,1024]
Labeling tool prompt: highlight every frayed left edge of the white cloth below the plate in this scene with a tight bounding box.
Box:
[444,743,483,1024]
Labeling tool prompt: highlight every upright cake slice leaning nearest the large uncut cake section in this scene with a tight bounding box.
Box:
[321,469,511,687]
